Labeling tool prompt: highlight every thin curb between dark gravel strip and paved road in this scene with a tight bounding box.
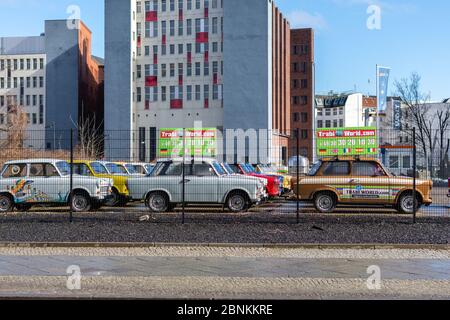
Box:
[0,242,450,250]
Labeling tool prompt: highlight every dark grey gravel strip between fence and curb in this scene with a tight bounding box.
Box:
[0,209,450,244]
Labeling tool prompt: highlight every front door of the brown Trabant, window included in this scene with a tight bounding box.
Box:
[350,161,391,204]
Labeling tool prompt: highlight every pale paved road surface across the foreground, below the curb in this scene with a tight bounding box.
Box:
[0,247,450,299]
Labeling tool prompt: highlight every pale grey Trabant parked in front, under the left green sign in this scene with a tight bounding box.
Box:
[127,159,265,212]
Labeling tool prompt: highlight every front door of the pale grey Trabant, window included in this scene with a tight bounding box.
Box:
[186,163,219,203]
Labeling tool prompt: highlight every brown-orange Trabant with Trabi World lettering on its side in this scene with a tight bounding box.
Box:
[292,157,433,213]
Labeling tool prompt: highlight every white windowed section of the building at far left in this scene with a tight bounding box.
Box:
[0,36,46,149]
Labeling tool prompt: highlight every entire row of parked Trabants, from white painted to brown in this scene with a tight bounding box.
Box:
[0,157,436,213]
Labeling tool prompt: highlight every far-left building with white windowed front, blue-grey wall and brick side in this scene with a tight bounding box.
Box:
[0,20,104,150]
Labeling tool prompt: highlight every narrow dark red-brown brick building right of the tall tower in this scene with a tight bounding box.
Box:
[289,29,314,161]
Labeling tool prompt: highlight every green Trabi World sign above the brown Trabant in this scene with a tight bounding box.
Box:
[316,127,379,157]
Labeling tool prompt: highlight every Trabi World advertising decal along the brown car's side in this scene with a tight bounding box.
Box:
[328,185,401,200]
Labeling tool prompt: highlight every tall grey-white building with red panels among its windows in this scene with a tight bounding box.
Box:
[105,0,290,165]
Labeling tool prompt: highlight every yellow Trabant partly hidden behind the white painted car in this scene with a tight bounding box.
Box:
[73,160,130,207]
